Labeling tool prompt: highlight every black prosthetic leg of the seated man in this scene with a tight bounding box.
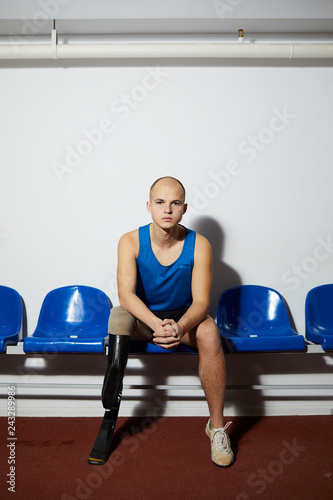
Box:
[88,335,129,465]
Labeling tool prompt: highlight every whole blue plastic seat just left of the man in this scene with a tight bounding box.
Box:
[23,285,112,353]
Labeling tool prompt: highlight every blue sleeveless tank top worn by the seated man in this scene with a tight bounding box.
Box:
[136,224,196,311]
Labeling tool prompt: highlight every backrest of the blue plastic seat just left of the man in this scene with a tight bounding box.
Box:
[36,285,111,336]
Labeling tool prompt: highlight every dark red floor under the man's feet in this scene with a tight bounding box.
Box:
[0,416,333,500]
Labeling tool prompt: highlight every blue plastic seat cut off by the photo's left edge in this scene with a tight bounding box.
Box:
[0,285,22,352]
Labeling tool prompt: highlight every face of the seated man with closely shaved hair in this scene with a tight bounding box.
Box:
[147,180,187,229]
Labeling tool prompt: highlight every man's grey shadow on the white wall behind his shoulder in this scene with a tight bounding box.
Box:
[191,216,242,318]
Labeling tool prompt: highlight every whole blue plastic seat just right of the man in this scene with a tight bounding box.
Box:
[217,285,305,352]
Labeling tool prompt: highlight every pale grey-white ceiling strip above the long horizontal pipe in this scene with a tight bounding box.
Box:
[0,0,333,35]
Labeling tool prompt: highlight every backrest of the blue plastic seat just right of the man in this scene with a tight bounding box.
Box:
[217,285,291,336]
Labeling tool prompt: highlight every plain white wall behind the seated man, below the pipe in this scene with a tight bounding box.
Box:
[0,61,333,334]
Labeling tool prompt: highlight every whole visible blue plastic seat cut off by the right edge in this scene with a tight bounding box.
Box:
[305,284,333,351]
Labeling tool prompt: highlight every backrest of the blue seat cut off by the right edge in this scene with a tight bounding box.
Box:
[305,284,333,330]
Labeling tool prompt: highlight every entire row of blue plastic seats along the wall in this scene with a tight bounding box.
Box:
[0,284,333,353]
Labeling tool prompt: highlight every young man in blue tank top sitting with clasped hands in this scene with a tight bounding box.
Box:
[88,177,234,467]
